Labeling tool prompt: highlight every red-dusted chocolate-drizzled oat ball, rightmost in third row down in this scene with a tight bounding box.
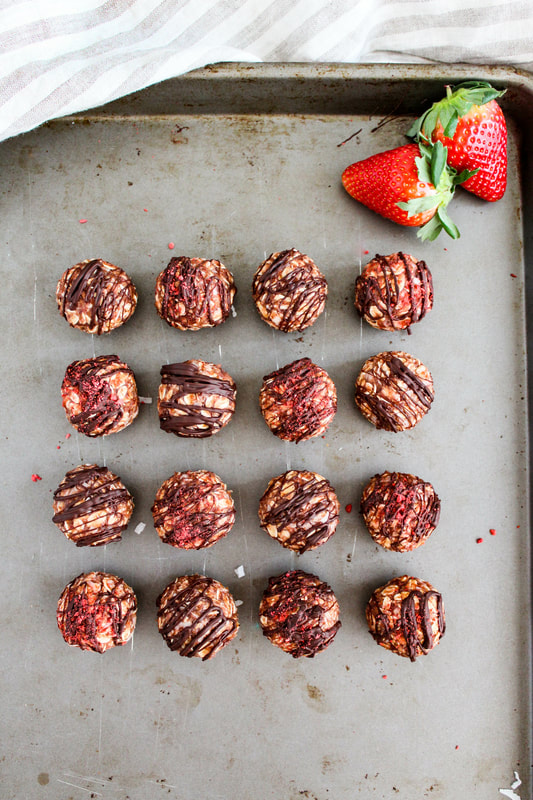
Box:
[361,472,440,553]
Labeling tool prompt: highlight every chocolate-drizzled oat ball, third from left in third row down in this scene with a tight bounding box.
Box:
[259,470,339,553]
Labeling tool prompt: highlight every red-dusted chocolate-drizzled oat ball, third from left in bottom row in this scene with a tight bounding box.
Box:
[259,570,341,658]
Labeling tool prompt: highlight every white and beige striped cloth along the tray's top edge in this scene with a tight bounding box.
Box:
[0,0,533,140]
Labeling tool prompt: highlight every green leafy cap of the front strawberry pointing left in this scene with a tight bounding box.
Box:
[397,141,472,241]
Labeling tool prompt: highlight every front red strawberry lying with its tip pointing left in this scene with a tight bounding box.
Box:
[342,143,459,240]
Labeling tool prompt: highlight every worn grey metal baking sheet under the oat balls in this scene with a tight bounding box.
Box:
[0,65,532,800]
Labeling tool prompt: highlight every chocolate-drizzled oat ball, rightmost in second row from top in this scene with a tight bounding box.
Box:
[355,351,434,432]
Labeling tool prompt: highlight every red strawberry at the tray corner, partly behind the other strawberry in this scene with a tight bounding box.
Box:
[408,81,507,201]
